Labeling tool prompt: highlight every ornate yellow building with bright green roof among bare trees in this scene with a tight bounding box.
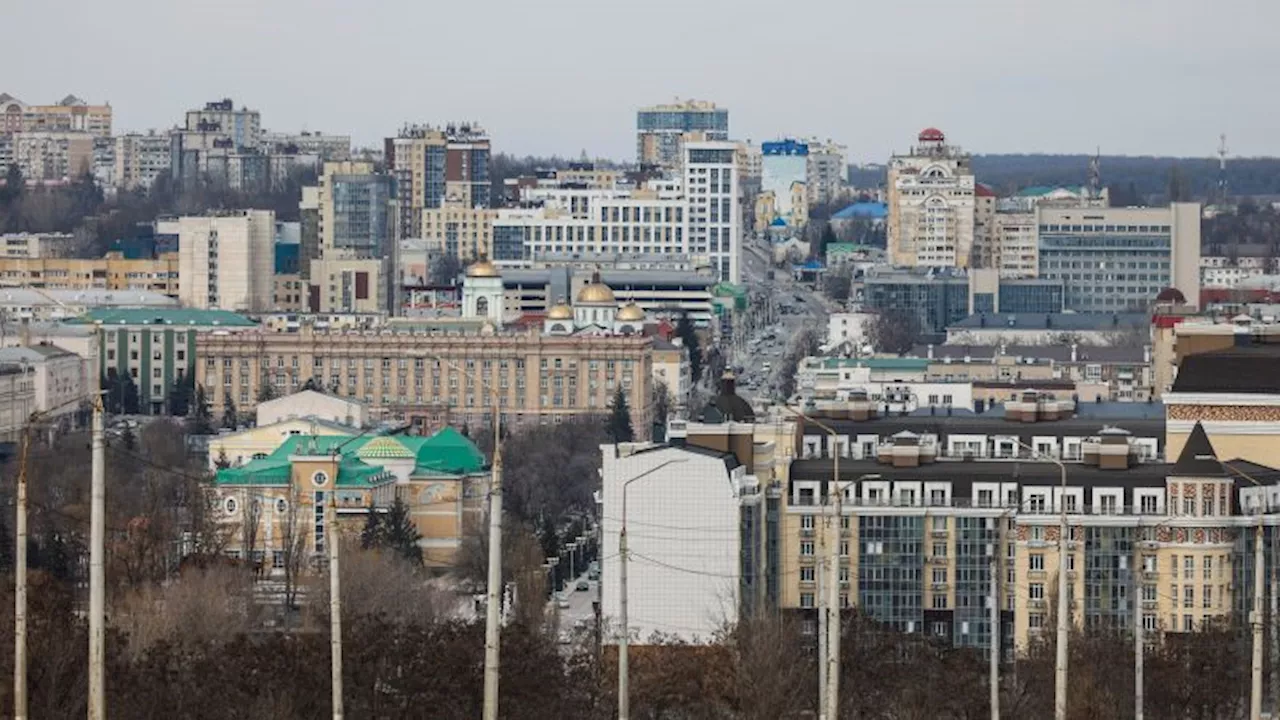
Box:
[211,428,489,566]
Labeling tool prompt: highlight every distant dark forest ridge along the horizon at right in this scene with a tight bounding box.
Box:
[849,155,1280,205]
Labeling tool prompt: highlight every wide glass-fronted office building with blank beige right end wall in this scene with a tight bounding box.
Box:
[1036,202,1201,313]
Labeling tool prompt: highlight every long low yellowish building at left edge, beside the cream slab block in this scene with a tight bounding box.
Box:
[0,252,178,297]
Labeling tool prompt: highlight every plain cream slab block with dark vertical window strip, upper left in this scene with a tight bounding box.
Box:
[178,210,275,313]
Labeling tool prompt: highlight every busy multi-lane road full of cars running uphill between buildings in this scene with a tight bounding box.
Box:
[728,230,835,397]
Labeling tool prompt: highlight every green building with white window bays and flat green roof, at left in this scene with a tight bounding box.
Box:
[70,307,257,415]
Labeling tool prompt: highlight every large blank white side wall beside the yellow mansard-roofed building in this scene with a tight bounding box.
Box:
[602,445,741,642]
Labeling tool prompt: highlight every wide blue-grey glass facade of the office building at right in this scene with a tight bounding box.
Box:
[1039,224,1172,313]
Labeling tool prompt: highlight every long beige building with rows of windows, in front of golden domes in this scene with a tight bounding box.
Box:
[196,325,653,437]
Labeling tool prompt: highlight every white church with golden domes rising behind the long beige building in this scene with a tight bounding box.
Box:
[462,259,649,336]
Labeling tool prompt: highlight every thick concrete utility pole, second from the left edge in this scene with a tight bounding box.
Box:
[88,395,106,720]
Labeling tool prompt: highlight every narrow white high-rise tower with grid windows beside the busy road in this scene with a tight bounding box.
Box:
[684,142,742,283]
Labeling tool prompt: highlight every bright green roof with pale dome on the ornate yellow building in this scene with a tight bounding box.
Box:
[215,428,486,487]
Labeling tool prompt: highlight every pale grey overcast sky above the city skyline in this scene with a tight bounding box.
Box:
[0,0,1280,163]
